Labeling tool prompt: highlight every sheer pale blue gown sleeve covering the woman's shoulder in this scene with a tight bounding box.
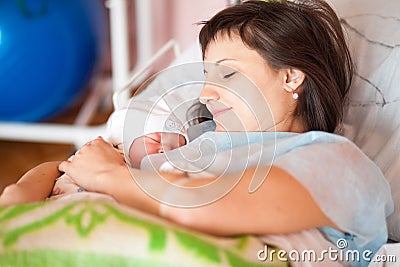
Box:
[273,132,393,252]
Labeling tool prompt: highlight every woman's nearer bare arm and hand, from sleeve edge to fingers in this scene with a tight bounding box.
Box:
[60,139,340,235]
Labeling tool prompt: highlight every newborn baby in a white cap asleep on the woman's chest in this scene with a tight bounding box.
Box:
[50,100,187,198]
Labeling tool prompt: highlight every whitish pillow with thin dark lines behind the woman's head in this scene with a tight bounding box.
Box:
[332,0,400,241]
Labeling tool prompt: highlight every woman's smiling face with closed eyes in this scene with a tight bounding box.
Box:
[200,34,295,131]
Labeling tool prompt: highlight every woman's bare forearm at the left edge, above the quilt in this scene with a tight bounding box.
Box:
[0,161,61,206]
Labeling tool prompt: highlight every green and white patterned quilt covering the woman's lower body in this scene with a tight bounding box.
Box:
[0,193,288,267]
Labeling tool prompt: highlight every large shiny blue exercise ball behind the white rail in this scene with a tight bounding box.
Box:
[0,0,107,121]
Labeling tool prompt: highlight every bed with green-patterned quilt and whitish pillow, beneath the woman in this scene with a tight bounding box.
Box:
[0,0,400,267]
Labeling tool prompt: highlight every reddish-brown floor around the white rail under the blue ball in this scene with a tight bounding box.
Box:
[0,97,110,193]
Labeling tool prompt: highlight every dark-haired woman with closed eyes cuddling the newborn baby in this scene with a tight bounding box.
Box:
[10,0,393,265]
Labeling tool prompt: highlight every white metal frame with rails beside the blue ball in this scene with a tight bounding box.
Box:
[0,0,179,148]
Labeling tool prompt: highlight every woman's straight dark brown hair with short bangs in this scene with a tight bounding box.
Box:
[199,0,353,132]
